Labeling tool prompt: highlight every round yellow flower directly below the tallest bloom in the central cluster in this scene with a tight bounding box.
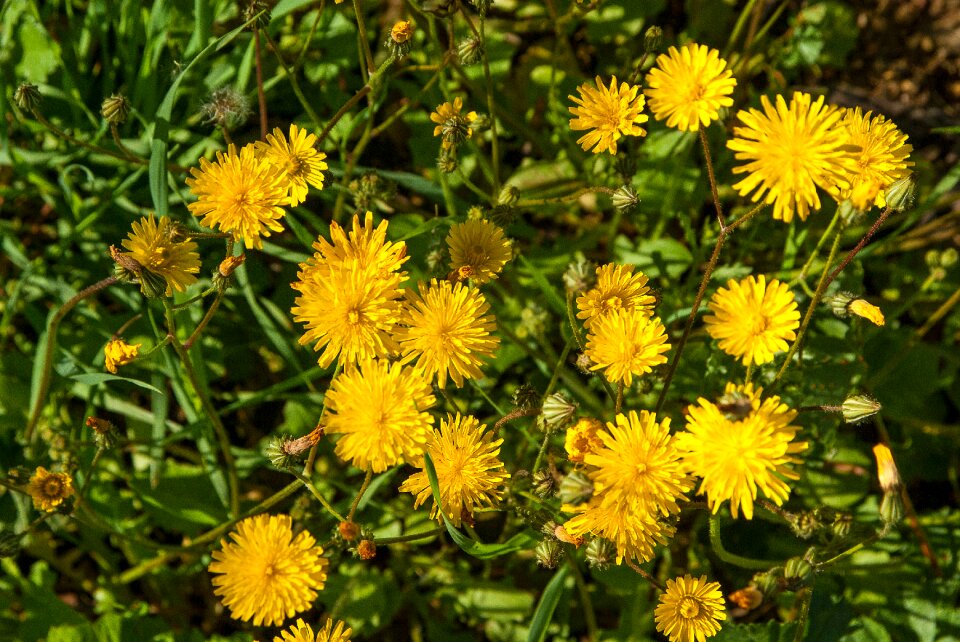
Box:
[326,359,436,473]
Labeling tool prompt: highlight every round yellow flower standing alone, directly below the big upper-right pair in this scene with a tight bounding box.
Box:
[703,274,800,365]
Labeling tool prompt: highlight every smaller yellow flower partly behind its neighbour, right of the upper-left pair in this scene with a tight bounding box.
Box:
[255,125,327,205]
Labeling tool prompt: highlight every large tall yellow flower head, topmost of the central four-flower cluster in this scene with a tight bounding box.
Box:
[291,212,407,367]
